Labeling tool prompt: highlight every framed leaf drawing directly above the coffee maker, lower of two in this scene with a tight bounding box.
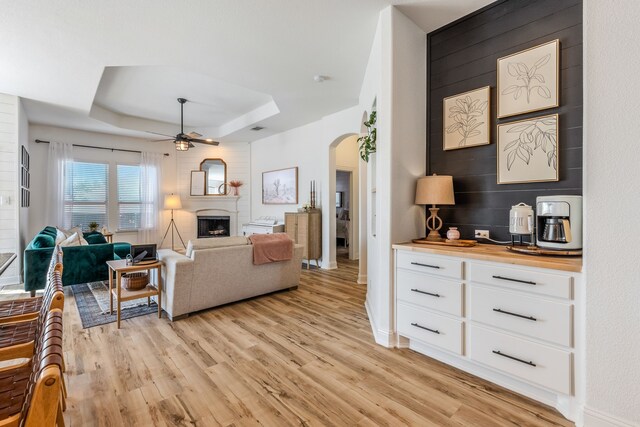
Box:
[497,114,559,184]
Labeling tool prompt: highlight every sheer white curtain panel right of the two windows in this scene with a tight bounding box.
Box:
[138,152,164,243]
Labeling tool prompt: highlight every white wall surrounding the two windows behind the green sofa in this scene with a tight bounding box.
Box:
[28,125,176,246]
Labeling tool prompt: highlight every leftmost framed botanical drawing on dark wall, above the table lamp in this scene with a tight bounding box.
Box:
[442,86,491,151]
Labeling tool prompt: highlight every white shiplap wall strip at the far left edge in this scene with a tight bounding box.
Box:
[0,94,20,284]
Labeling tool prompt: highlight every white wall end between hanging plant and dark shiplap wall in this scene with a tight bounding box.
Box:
[367,7,426,346]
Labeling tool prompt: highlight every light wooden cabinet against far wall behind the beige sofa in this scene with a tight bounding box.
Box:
[284,209,322,269]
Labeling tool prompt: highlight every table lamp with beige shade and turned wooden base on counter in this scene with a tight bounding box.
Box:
[416,173,456,241]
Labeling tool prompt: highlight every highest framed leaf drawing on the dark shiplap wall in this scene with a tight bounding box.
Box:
[497,40,560,119]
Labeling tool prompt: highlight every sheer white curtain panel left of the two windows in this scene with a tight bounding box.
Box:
[45,141,73,228]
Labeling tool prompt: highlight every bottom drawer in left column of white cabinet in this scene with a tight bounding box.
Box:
[397,303,463,354]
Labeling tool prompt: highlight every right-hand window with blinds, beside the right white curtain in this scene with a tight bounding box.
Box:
[117,165,142,230]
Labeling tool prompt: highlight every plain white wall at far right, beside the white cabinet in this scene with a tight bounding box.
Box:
[584,0,640,426]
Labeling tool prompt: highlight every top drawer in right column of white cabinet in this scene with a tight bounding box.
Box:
[469,263,572,299]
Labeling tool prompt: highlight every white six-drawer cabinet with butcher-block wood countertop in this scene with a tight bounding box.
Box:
[393,244,584,420]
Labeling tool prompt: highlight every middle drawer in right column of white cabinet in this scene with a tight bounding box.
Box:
[469,285,573,347]
